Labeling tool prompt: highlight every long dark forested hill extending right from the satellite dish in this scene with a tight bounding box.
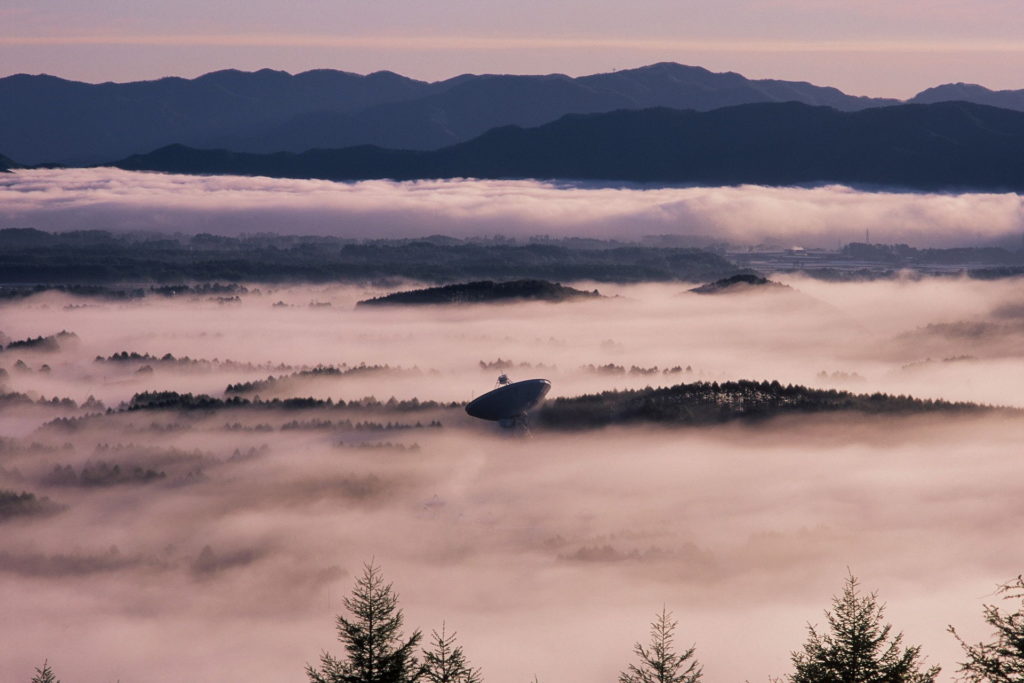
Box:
[537,380,1007,429]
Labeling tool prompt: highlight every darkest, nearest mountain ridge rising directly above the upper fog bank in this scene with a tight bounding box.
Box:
[116,102,1024,190]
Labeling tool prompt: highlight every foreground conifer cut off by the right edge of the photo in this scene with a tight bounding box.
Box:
[949,574,1024,683]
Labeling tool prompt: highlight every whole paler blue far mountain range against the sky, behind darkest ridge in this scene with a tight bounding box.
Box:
[0,62,1024,164]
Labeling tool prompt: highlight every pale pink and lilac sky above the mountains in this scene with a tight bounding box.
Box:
[6,0,1024,97]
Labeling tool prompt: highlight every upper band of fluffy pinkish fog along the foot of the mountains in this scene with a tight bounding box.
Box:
[6,168,1024,248]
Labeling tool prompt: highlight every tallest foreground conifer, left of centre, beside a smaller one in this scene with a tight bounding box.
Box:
[306,562,422,683]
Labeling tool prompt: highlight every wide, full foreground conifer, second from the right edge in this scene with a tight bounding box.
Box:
[788,574,939,683]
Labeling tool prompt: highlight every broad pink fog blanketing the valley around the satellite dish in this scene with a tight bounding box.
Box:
[0,279,1024,683]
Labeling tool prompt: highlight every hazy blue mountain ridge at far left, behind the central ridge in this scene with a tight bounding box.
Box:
[0,69,430,164]
